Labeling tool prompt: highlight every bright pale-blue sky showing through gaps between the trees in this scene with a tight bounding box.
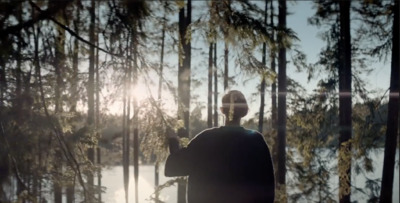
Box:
[101,1,390,118]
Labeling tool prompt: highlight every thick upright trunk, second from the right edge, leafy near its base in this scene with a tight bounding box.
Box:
[338,1,352,203]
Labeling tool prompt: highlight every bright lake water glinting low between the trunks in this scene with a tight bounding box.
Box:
[102,150,400,203]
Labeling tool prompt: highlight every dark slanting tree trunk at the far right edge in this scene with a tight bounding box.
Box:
[380,1,400,202]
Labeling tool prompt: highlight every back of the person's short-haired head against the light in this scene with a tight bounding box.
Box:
[221,90,249,121]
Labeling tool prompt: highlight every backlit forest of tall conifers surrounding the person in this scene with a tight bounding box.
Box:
[0,0,400,203]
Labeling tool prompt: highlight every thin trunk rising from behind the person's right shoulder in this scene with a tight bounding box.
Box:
[258,0,268,133]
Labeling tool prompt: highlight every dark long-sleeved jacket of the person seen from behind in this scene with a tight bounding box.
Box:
[165,126,275,203]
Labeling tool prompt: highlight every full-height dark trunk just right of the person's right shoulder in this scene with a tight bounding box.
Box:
[277,0,287,202]
